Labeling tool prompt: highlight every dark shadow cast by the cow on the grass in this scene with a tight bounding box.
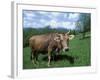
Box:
[43,55,76,64]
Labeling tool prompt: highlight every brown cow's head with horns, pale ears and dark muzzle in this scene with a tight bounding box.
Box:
[59,32,74,51]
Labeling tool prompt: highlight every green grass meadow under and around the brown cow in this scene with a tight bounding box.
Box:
[23,35,91,69]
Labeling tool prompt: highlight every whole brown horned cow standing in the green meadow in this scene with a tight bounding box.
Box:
[29,33,74,66]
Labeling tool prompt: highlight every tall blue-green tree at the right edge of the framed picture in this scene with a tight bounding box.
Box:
[76,13,91,38]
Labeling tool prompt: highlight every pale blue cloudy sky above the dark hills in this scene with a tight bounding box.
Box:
[23,10,79,29]
